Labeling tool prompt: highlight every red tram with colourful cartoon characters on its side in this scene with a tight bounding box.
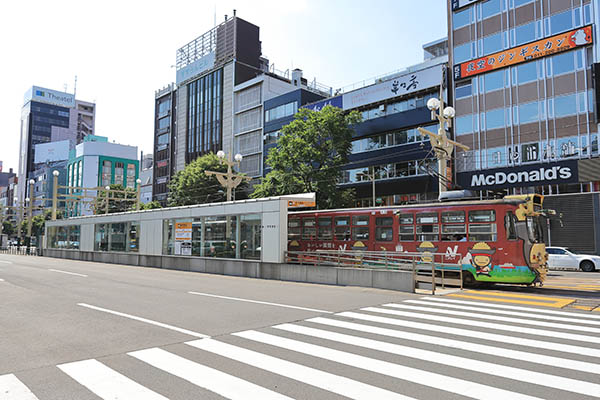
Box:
[288,194,548,284]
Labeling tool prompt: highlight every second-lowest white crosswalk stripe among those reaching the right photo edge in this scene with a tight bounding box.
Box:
[304,317,600,374]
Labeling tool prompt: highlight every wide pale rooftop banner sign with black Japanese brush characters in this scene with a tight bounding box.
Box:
[342,65,442,110]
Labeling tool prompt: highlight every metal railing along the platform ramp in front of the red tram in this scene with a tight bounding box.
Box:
[285,250,463,294]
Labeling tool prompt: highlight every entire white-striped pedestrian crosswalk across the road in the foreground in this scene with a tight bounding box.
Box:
[0,297,600,400]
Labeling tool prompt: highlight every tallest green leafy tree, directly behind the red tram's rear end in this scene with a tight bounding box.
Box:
[252,106,360,209]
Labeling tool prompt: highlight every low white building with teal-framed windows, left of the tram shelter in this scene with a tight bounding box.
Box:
[67,136,140,216]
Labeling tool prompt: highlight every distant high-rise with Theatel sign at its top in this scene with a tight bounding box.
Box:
[18,86,96,201]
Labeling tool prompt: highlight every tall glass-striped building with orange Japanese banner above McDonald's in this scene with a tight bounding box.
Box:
[448,0,600,195]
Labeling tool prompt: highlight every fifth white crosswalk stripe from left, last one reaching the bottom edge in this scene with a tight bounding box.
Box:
[233,331,535,400]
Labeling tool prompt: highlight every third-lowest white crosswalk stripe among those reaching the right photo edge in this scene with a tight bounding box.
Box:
[335,311,600,357]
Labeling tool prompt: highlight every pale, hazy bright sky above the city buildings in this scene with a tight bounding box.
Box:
[0,0,447,171]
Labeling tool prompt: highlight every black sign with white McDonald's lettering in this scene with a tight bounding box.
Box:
[456,160,579,190]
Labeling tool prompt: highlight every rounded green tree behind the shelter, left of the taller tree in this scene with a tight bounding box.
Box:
[169,153,248,207]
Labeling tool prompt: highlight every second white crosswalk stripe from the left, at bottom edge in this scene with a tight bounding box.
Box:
[57,360,168,400]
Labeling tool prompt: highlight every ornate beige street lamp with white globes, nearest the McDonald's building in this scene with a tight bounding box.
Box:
[417,89,469,194]
